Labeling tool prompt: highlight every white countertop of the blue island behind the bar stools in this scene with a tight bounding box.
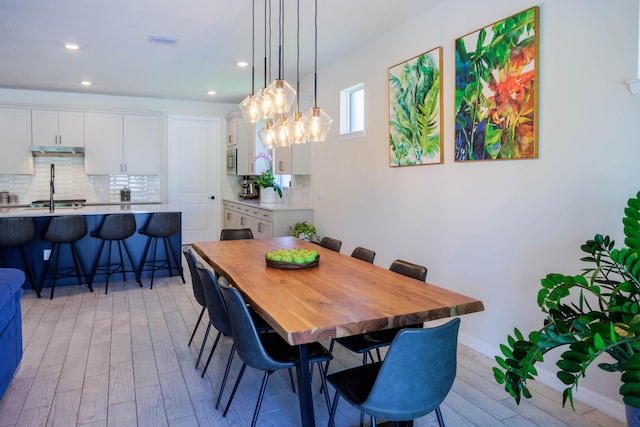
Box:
[0,202,181,217]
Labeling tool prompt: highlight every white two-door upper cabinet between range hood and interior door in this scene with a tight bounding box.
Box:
[84,113,160,175]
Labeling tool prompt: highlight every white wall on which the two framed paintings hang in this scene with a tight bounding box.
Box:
[305,0,640,417]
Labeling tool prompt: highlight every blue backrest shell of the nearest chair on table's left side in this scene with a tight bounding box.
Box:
[218,277,294,371]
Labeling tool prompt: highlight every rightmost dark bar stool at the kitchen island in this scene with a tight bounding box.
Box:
[138,212,187,289]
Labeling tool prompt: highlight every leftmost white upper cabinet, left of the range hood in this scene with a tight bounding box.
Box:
[0,108,33,174]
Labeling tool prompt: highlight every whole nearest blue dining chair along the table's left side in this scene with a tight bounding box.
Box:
[218,277,331,427]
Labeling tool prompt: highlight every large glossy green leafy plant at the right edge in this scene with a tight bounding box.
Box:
[493,192,640,425]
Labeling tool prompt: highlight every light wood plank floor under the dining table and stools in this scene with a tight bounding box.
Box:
[0,256,624,427]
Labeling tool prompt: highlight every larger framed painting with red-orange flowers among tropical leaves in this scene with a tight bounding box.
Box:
[455,7,540,162]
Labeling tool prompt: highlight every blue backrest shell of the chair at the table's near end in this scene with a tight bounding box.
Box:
[360,318,460,421]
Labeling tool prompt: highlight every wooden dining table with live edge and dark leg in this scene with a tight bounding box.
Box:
[192,237,484,427]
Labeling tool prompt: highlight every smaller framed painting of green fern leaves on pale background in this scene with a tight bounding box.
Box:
[389,47,443,167]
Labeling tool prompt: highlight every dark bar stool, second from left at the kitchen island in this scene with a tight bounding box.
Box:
[40,215,93,299]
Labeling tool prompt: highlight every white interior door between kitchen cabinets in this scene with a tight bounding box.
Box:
[168,116,220,244]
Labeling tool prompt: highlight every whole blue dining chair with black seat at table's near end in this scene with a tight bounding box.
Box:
[327,318,460,427]
